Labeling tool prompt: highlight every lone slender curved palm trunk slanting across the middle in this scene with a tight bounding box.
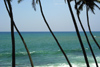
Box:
[39,0,72,67]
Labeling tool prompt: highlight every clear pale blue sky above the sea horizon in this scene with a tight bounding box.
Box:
[0,0,100,32]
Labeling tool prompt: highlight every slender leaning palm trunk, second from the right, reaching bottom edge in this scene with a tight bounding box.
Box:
[75,0,98,67]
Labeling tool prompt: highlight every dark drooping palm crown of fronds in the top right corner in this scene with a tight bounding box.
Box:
[75,0,100,13]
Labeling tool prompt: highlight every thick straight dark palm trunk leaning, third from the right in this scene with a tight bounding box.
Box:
[67,0,89,67]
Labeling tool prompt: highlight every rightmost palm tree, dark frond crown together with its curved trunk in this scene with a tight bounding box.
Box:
[75,0,100,49]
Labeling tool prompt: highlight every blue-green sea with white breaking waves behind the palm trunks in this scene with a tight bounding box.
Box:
[0,32,100,67]
